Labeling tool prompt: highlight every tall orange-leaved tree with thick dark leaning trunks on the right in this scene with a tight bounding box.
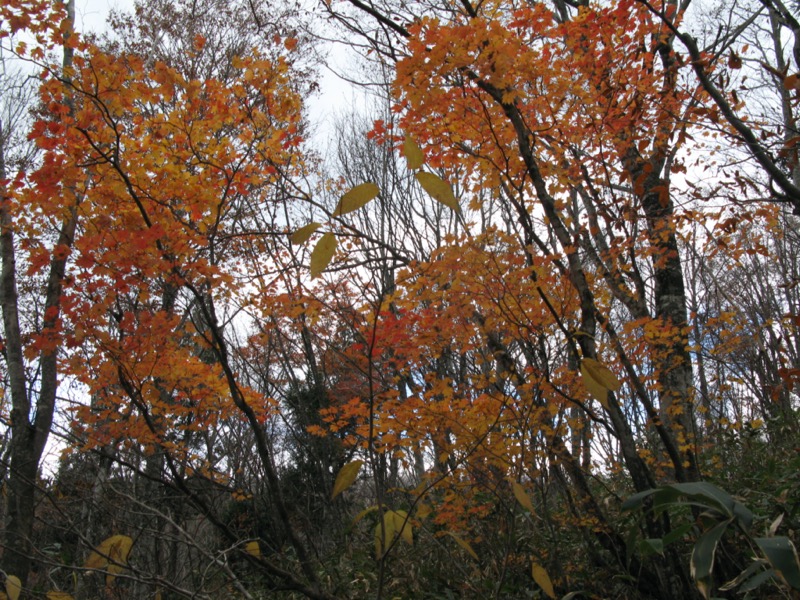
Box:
[310,0,794,597]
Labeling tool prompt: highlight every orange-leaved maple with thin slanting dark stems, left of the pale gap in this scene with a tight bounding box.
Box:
[3,4,340,597]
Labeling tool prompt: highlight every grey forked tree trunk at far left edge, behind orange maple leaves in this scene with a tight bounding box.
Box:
[0,2,81,583]
